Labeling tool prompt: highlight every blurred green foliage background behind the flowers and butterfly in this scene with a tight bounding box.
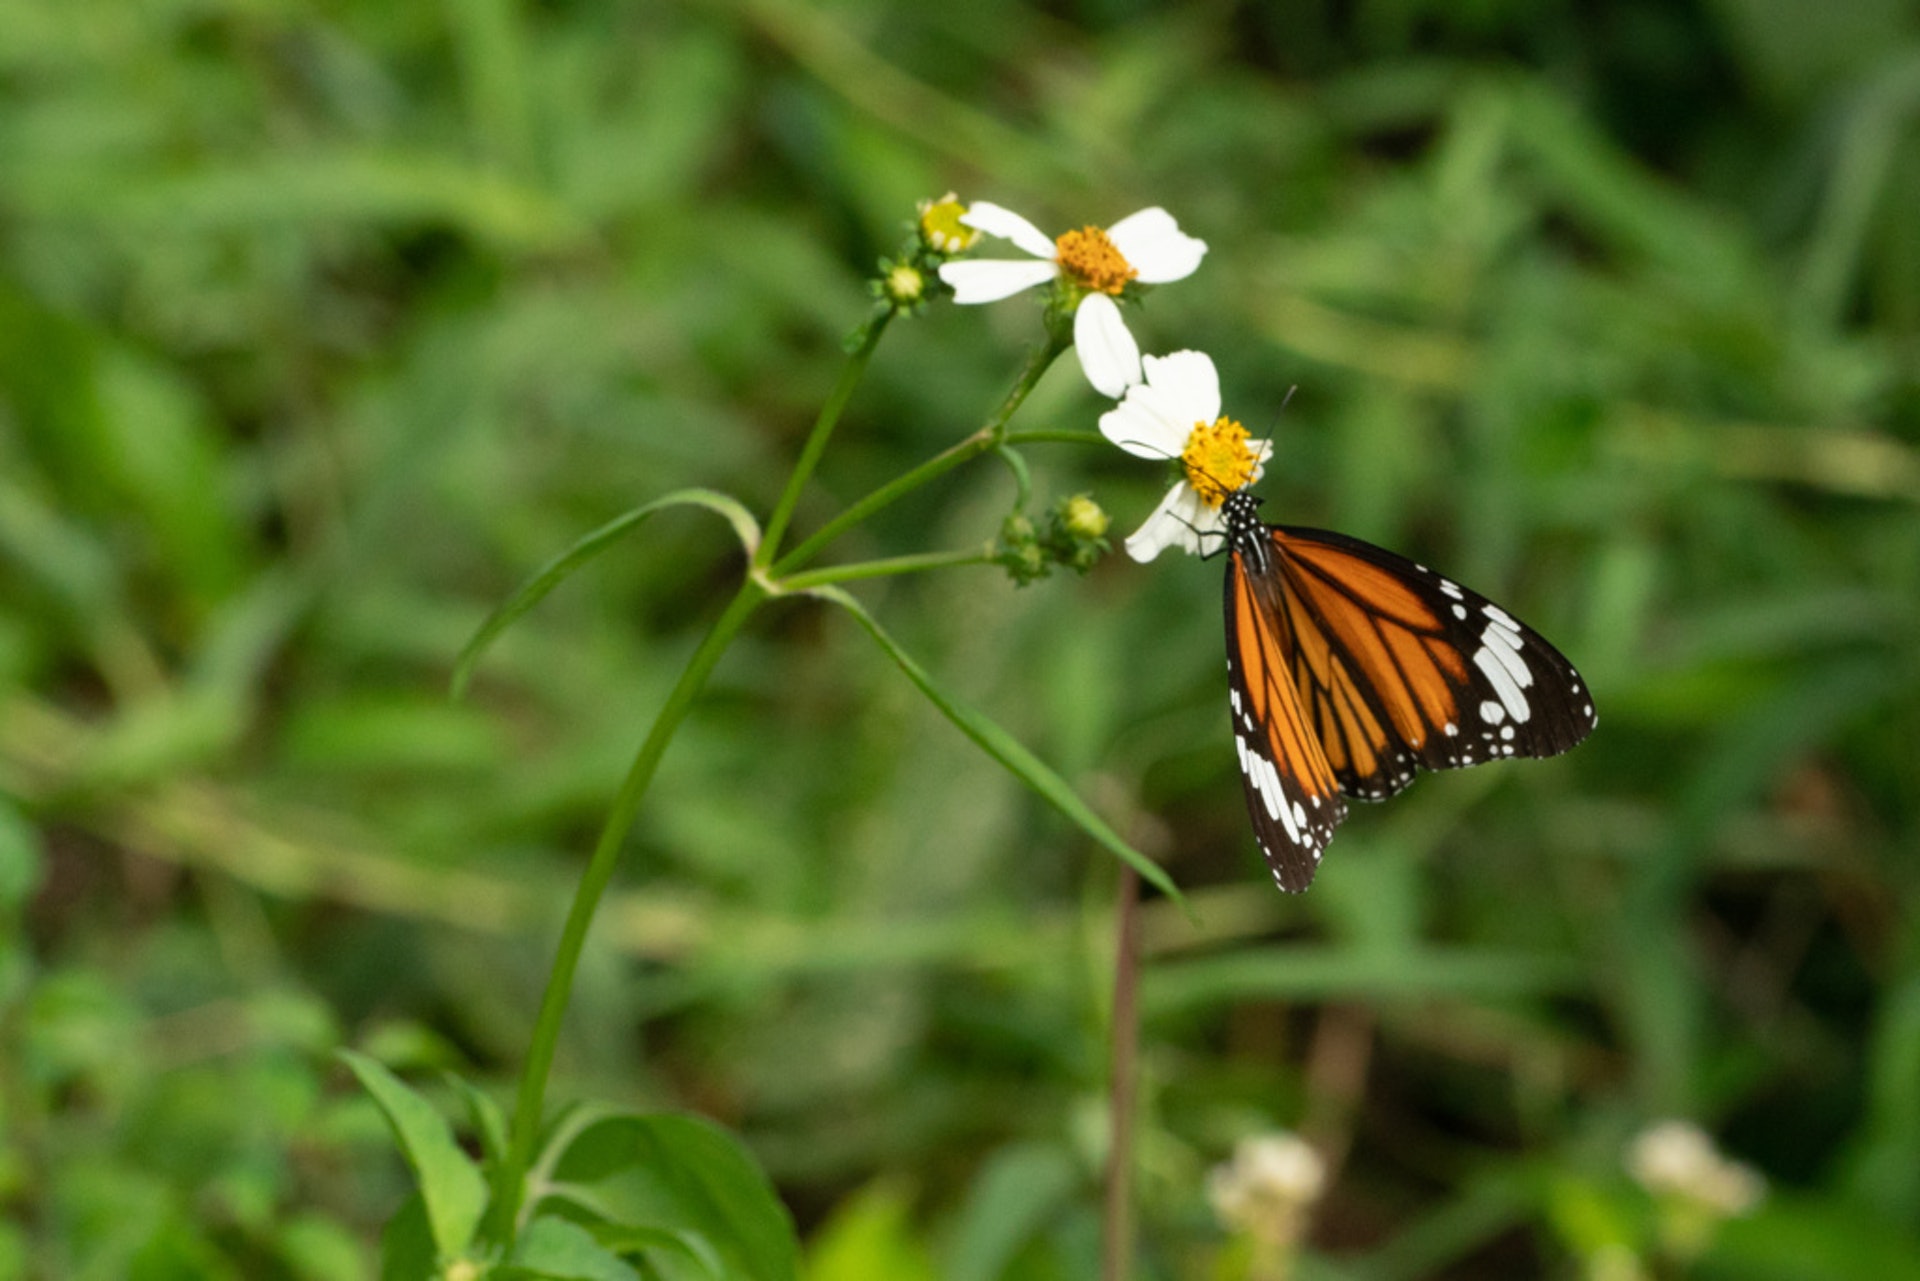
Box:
[0,0,1920,1281]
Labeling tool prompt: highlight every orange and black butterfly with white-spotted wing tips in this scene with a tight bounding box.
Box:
[1221,490,1594,891]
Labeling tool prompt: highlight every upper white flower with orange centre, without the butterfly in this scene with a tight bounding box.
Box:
[941,200,1206,399]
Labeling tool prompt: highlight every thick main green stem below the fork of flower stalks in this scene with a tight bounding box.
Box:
[488,578,768,1245]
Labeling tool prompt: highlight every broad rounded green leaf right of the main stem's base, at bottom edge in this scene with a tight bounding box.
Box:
[555,1114,799,1281]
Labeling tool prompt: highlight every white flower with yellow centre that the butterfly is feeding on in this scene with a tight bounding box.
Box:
[1100,351,1273,563]
